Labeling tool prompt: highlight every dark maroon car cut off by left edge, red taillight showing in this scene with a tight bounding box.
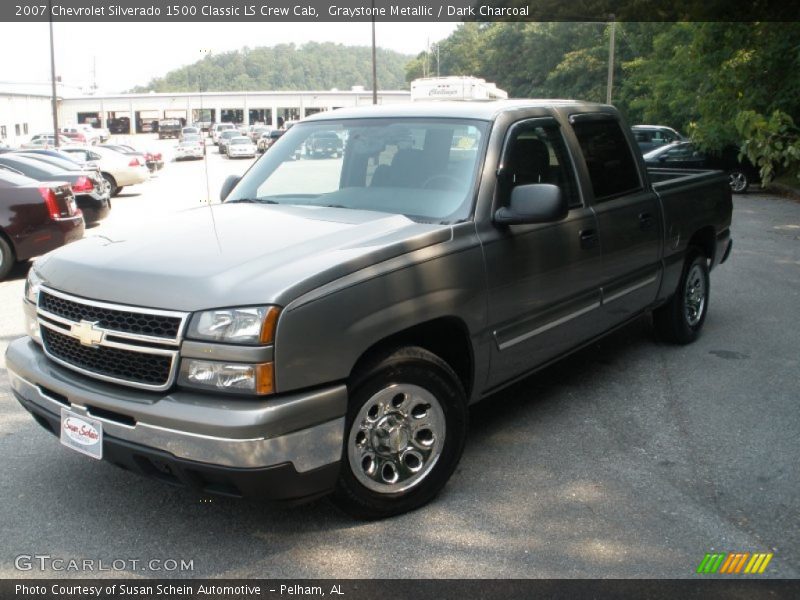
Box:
[0,168,84,279]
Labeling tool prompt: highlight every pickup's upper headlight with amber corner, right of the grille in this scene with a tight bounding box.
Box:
[186,306,280,344]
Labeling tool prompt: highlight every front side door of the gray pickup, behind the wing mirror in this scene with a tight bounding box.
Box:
[479,117,601,389]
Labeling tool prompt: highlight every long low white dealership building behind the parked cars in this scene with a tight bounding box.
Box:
[0,86,411,146]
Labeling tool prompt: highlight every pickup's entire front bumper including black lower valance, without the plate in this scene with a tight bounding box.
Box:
[6,338,347,501]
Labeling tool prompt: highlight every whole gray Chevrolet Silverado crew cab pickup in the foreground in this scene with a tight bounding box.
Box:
[6,100,732,518]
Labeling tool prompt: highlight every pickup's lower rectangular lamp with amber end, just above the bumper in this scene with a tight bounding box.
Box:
[178,358,275,396]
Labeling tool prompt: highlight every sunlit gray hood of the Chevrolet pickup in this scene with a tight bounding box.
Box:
[36,203,452,311]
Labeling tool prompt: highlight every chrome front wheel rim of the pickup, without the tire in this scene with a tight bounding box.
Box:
[347,383,446,494]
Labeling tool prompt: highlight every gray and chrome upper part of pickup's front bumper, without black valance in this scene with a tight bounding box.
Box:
[6,338,347,473]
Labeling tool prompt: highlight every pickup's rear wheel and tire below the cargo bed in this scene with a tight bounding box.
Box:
[653,248,710,344]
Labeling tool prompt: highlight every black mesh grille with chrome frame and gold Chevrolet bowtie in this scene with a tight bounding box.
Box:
[37,286,188,390]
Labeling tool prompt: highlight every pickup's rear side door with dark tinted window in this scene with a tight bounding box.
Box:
[570,113,664,328]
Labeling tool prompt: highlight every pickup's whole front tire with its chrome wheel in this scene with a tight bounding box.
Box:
[332,346,468,519]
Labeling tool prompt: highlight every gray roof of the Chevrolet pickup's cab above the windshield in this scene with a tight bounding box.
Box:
[303,98,614,121]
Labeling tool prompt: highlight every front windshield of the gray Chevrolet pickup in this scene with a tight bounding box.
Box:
[226,118,489,222]
